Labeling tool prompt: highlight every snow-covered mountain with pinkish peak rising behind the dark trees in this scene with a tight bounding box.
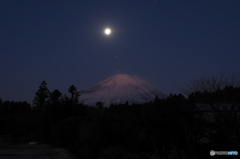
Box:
[80,74,168,107]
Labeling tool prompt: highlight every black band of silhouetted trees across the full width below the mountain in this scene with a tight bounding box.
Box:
[0,81,240,159]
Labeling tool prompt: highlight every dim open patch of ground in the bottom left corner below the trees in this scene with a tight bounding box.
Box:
[0,144,77,159]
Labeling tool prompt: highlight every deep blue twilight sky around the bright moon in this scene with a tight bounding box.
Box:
[0,0,240,102]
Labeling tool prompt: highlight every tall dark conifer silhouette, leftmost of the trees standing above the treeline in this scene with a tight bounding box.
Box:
[33,81,50,109]
